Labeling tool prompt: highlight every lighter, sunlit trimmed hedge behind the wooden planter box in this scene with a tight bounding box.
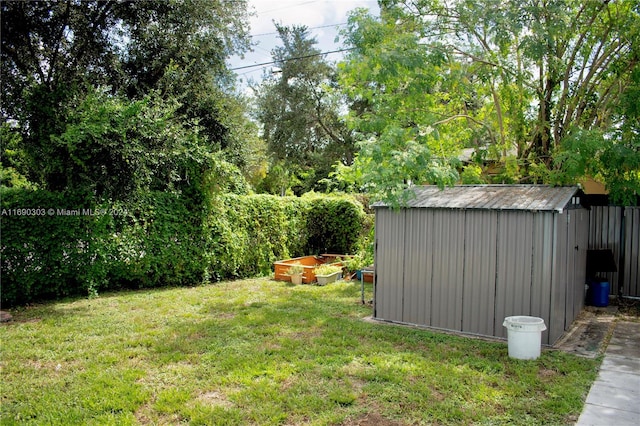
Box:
[209,195,366,279]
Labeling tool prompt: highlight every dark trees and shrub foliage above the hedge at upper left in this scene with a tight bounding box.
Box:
[1,0,255,195]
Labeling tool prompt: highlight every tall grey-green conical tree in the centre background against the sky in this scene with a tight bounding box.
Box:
[256,24,354,191]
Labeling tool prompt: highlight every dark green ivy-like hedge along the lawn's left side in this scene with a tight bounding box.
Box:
[0,188,206,305]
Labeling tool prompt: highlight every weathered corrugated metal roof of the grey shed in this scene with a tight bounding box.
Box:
[373,185,578,212]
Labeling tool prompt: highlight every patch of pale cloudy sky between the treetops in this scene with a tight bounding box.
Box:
[229,0,379,85]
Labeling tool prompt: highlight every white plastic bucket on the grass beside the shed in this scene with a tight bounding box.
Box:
[502,316,547,359]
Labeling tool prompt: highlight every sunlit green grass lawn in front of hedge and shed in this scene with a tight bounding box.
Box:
[0,279,597,425]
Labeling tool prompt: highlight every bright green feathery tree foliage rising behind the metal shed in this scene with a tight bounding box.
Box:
[340,0,640,205]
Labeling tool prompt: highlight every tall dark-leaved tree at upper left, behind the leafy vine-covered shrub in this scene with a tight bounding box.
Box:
[1,0,248,194]
